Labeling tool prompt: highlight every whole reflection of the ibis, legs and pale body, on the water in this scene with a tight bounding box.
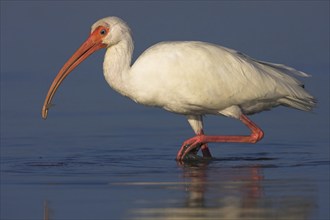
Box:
[133,161,315,220]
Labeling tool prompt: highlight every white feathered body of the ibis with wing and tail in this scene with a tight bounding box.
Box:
[131,41,312,114]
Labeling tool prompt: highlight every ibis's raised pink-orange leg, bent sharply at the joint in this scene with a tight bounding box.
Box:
[176,115,264,160]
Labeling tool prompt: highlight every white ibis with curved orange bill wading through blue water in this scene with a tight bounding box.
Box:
[42,16,316,161]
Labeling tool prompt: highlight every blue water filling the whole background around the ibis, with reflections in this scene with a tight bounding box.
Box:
[0,1,330,220]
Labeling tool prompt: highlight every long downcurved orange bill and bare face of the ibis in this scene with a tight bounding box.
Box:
[41,27,107,119]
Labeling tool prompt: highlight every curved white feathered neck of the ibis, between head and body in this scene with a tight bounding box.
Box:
[103,34,134,96]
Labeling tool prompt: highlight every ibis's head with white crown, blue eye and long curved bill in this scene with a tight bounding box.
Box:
[41,17,130,119]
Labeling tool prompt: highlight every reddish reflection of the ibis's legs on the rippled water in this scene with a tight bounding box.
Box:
[179,160,263,212]
